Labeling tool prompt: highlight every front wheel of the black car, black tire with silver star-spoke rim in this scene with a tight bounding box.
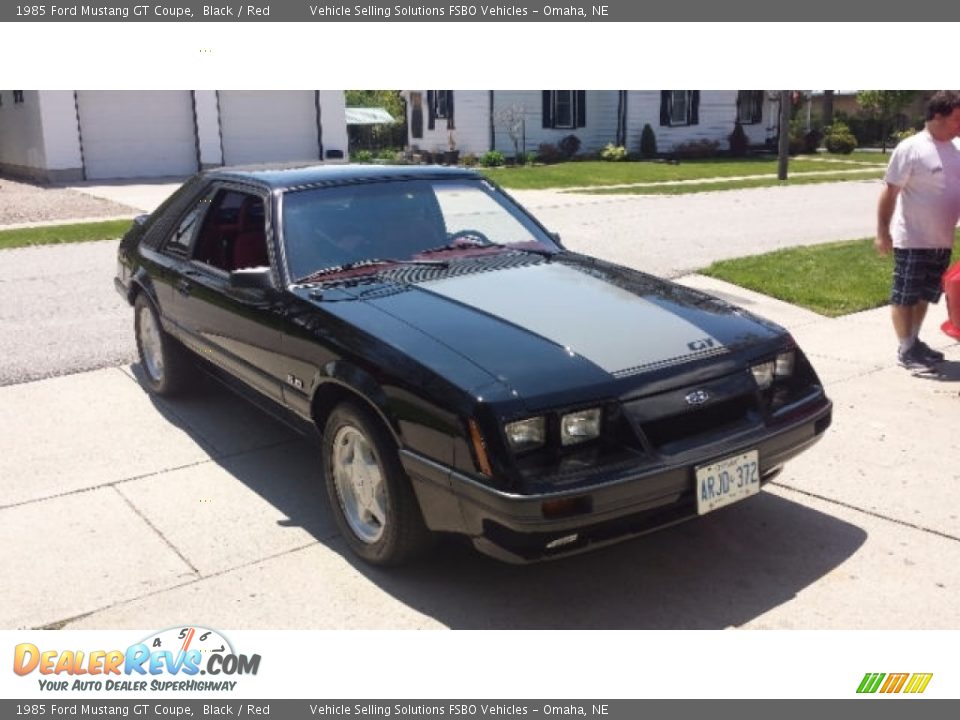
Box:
[323,402,431,565]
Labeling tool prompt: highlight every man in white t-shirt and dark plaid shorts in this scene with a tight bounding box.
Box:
[874,90,960,370]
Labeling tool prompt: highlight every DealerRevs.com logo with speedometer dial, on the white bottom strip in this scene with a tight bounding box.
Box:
[13,626,260,692]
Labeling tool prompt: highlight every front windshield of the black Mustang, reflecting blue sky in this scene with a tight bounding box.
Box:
[282,178,559,278]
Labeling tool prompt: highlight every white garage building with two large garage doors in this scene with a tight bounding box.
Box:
[0,90,347,182]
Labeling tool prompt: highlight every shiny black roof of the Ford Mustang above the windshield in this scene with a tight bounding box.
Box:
[203,164,480,190]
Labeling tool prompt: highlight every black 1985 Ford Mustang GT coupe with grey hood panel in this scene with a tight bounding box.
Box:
[116,165,831,564]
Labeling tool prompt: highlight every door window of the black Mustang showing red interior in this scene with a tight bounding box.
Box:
[193,190,270,272]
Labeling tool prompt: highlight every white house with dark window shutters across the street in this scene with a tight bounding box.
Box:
[404,90,778,155]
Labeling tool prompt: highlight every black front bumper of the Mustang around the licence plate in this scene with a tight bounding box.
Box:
[401,399,833,563]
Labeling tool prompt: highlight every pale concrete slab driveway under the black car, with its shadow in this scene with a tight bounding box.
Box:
[0,276,960,629]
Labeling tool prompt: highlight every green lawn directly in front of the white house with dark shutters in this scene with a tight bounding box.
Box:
[481,156,884,190]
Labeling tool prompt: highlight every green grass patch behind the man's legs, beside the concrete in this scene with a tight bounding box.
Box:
[700,232,960,317]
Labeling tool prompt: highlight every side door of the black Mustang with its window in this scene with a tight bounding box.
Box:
[171,183,282,402]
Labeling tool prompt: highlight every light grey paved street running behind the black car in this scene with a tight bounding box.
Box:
[0,181,879,386]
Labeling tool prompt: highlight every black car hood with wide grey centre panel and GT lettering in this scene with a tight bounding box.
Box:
[306,255,784,404]
